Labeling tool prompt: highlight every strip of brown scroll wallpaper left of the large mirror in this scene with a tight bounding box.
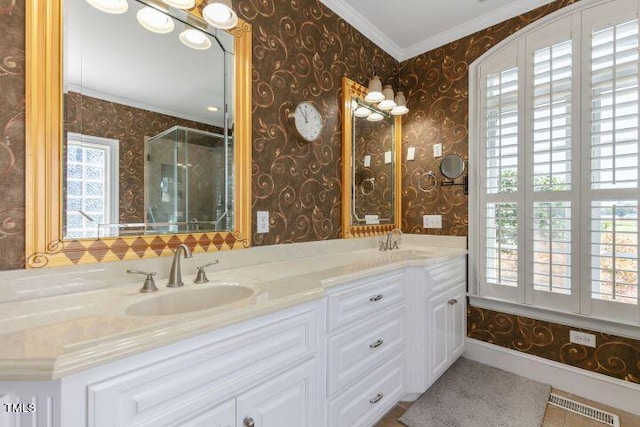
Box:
[0,0,25,270]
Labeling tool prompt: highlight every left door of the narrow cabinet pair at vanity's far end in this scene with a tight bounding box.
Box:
[429,294,449,382]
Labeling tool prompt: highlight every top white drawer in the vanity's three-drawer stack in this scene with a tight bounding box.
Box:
[327,273,404,331]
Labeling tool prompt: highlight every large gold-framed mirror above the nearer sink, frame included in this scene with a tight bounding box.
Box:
[25,0,251,268]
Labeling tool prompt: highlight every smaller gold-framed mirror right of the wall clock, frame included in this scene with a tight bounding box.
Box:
[342,77,402,238]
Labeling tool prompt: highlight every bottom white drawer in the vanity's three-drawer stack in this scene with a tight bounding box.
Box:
[329,353,404,427]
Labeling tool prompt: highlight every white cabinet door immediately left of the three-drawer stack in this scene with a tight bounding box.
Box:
[236,359,319,427]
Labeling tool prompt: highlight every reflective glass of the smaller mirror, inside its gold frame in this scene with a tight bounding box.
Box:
[351,97,395,225]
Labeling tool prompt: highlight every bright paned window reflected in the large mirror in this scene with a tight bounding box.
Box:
[64,133,118,239]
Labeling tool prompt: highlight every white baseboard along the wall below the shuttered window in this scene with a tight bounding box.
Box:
[463,338,640,415]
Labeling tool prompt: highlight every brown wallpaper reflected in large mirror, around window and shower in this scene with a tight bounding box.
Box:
[65,92,222,223]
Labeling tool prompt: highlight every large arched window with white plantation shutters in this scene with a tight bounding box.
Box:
[470,0,640,324]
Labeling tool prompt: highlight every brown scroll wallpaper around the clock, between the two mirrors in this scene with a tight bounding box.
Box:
[234,0,399,245]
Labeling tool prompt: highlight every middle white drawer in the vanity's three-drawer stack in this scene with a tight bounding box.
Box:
[327,305,404,395]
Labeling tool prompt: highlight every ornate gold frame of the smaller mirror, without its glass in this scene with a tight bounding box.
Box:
[342,76,402,239]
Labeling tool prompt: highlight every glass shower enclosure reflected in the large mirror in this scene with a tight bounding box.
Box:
[145,126,233,234]
